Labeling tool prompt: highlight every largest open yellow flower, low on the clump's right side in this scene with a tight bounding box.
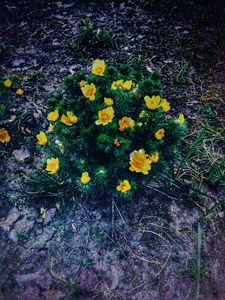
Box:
[129,149,151,175]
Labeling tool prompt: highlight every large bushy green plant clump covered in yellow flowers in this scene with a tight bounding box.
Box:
[36,59,186,196]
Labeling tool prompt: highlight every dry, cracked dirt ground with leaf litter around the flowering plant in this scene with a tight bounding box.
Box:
[0,0,225,300]
